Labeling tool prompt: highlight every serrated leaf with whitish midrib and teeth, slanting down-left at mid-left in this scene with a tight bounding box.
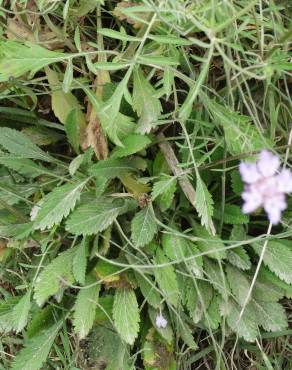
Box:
[33,180,88,230]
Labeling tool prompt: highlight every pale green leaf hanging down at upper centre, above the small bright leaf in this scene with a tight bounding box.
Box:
[133,68,162,134]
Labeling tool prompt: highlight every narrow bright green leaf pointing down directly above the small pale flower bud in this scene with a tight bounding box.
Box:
[153,248,180,307]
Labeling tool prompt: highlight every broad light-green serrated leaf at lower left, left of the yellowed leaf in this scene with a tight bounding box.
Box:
[34,248,76,306]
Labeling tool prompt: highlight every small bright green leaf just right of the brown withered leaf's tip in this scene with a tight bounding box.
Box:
[111,134,151,158]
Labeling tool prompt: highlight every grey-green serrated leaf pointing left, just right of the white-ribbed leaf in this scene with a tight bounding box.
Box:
[66,198,127,235]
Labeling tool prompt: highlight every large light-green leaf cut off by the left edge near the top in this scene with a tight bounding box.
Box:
[0,40,68,82]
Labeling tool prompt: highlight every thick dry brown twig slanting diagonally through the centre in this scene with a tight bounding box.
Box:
[157,133,196,207]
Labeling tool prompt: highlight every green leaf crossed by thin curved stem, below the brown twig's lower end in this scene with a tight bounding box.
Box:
[192,222,226,259]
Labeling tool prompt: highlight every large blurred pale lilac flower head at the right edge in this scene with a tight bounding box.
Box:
[239,150,292,225]
